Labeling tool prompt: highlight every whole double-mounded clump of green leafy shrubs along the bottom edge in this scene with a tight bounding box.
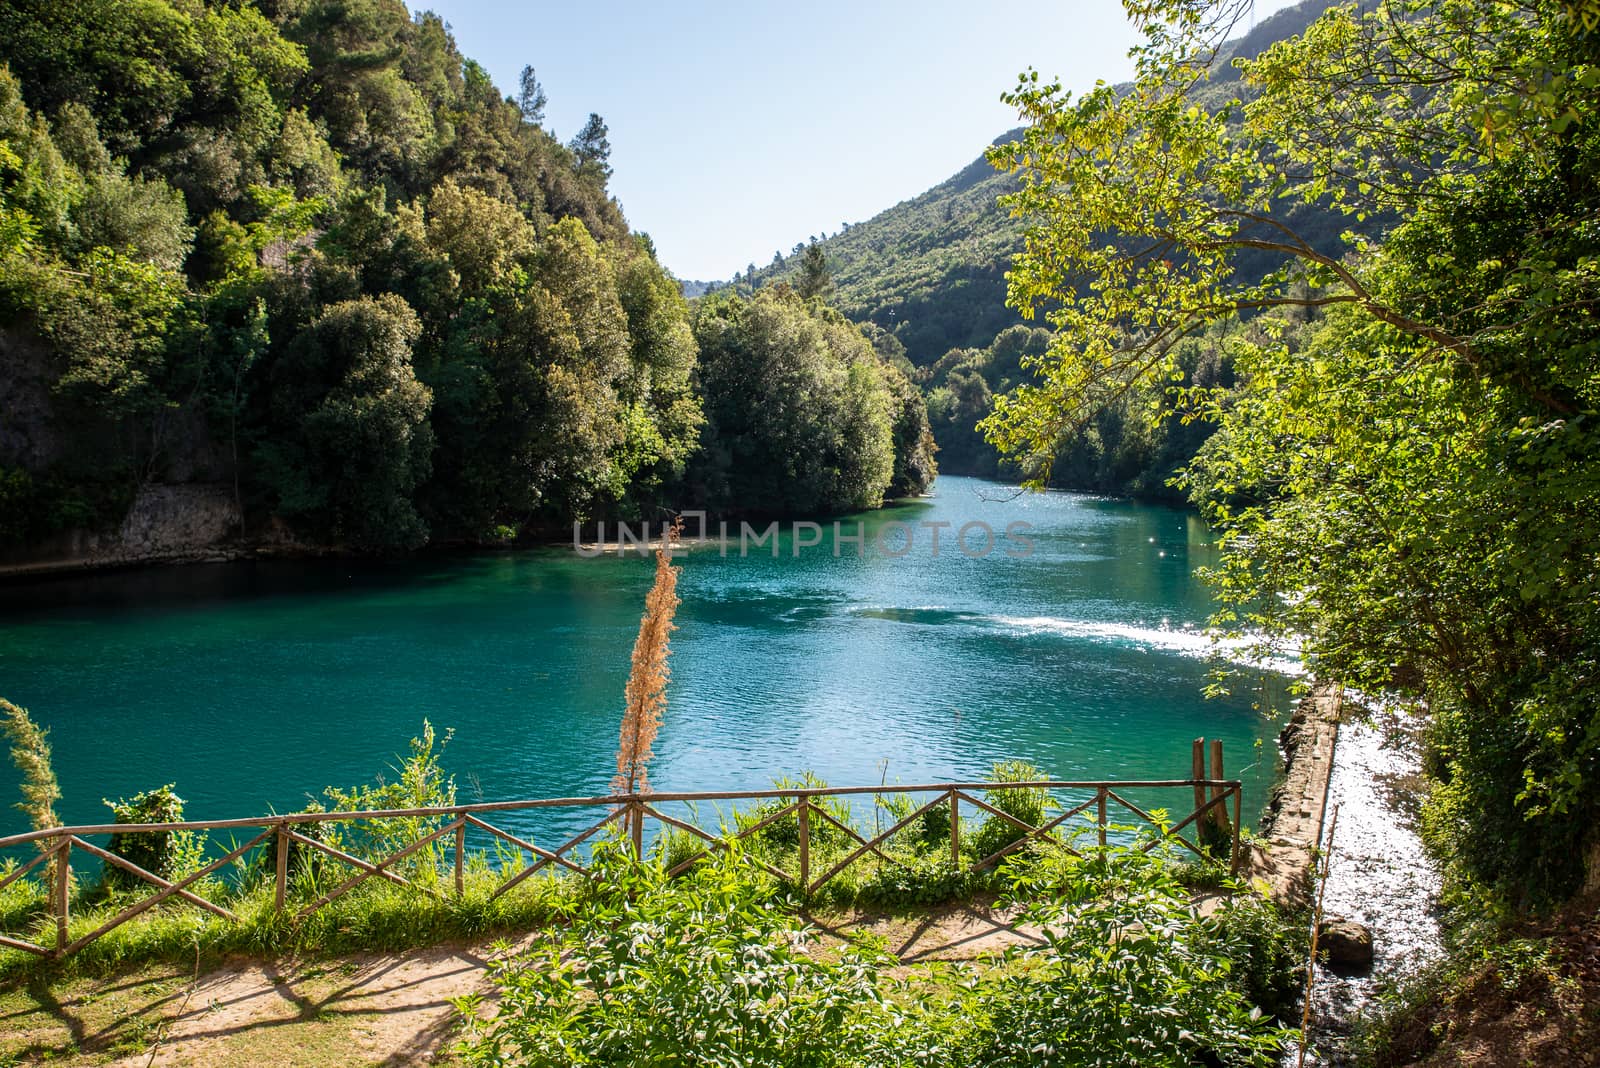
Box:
[459,844,1280,1068]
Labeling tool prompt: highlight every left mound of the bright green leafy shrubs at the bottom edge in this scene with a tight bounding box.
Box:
[461,846,893,1066]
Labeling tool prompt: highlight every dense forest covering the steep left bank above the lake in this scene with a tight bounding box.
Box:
[0,0,933,550]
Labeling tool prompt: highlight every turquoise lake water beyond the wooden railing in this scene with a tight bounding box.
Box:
[0,478,1274,833]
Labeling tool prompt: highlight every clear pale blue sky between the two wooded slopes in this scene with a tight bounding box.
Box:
[411,0,1286,280]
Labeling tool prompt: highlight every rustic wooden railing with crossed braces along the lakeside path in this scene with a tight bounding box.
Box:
[0,777,1243,958]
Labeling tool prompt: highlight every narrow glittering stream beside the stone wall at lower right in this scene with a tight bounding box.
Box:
[1285,713,1443,1066]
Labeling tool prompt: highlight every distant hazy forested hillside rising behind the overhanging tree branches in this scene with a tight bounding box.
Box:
[733,0,1346,366]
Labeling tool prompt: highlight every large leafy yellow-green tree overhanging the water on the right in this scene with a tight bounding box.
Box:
[984,0,1600,905]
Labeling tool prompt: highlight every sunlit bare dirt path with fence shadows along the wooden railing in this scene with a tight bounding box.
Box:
[0,902,1037,1068]
